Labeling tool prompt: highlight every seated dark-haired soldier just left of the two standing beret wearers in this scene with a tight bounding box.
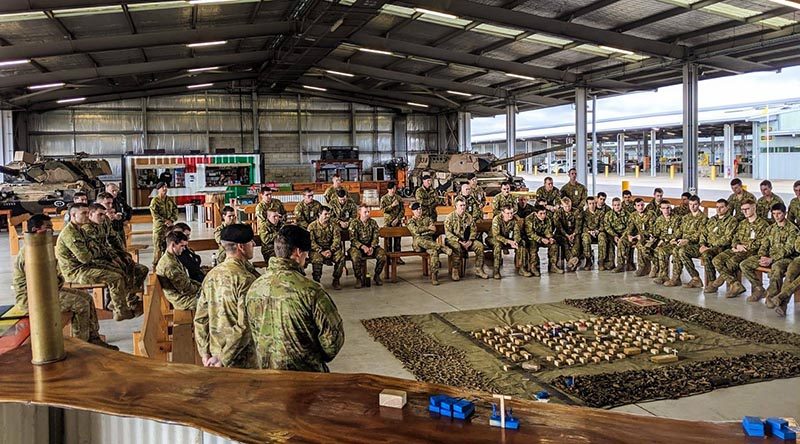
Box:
[156,231,202,310]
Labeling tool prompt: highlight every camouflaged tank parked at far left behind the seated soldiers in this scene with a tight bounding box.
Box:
[0,152,111,216]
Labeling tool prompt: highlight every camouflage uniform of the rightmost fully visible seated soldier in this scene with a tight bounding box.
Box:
[739,218,798,295]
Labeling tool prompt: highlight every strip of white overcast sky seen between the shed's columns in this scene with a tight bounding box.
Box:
[472,63,800,135]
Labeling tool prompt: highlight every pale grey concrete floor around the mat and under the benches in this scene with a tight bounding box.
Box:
[0,219,800,420]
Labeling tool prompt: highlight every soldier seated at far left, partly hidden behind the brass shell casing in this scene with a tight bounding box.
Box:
[12,214,119,350]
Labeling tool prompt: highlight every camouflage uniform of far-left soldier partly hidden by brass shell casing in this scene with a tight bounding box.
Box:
[13,246,100,341]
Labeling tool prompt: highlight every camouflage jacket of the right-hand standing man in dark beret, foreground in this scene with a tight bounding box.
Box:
[244,257,344,372]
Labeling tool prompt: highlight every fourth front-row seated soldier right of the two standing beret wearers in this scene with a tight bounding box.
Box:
[444,198,489,281]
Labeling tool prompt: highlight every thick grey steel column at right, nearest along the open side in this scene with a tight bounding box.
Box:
[683,63,699,194]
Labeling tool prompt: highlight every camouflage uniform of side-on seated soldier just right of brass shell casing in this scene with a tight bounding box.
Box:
[56,222,135,317]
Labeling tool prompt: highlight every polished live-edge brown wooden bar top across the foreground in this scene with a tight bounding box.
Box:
[0,338,778,444]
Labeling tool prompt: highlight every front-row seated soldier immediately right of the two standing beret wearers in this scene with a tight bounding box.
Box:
[308,206,345,290]
